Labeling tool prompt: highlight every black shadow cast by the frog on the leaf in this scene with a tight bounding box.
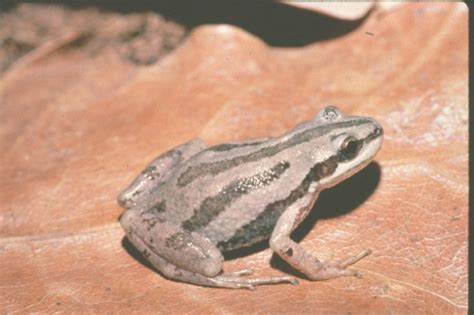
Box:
[122,162,381,277]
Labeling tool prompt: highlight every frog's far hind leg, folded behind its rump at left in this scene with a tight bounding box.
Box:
[117,139,207,209]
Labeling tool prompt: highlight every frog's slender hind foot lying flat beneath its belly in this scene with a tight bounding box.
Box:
[209,269,298,290]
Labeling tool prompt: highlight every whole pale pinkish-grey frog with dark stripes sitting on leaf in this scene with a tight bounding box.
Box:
[117,106,383,289]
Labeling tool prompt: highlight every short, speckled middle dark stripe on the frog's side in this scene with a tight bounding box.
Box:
[182,161,290,231]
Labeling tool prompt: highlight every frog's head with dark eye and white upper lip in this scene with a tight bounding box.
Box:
[313,106,383,187]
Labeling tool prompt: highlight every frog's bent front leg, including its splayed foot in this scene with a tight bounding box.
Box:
[270,192,371,280]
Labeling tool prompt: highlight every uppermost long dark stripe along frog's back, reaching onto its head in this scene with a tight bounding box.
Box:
[178,119,367,187]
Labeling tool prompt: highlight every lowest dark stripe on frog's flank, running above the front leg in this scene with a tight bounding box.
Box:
[217,155,339,251]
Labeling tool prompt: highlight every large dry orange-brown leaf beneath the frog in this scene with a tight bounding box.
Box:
[0,3,468,314]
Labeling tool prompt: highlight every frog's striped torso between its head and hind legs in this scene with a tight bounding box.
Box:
[153,134,322,251]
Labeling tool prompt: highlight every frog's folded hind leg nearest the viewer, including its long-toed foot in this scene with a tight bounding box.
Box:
[120,209,297,289]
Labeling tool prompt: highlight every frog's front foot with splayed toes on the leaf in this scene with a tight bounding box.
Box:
[311,249,372,280]
